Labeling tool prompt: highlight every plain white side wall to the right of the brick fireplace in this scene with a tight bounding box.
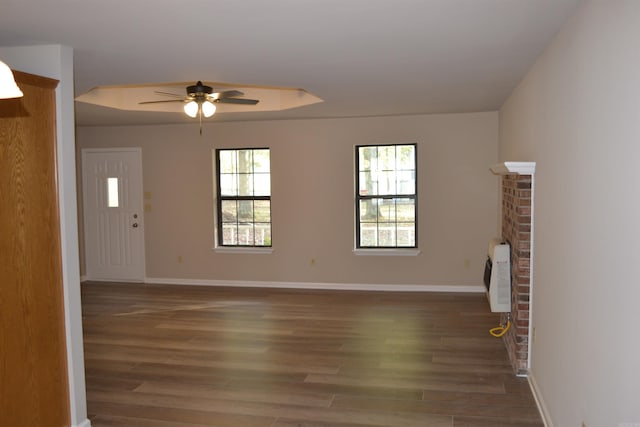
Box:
[500,0,640,427]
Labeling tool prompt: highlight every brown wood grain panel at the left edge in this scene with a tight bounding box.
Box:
[0,72,69,426]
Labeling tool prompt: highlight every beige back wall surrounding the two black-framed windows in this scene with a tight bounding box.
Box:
[77,112,498,286]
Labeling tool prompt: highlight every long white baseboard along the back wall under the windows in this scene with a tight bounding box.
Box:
[144,277,486,293]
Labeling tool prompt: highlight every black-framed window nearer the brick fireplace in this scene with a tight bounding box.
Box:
[356,144,417,249]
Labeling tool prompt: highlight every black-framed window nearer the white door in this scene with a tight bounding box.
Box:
[216,148,271,247]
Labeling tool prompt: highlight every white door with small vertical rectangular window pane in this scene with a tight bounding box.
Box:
[82,148,145,282]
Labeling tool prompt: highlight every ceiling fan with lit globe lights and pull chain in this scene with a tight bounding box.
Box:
[138,80,259,135]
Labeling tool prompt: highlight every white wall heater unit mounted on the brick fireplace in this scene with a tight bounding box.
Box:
[484,239,511,313]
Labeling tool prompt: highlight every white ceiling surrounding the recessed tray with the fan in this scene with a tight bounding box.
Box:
[0,0,580,125]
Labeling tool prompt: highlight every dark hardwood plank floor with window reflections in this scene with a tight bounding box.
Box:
[82,283,543,427]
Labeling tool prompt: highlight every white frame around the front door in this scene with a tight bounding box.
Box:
[81,147,146,282]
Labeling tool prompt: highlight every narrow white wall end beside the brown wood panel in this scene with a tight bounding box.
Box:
[0,45,89,427]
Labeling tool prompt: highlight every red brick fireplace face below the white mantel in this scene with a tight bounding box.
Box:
[502,175,532,375]
